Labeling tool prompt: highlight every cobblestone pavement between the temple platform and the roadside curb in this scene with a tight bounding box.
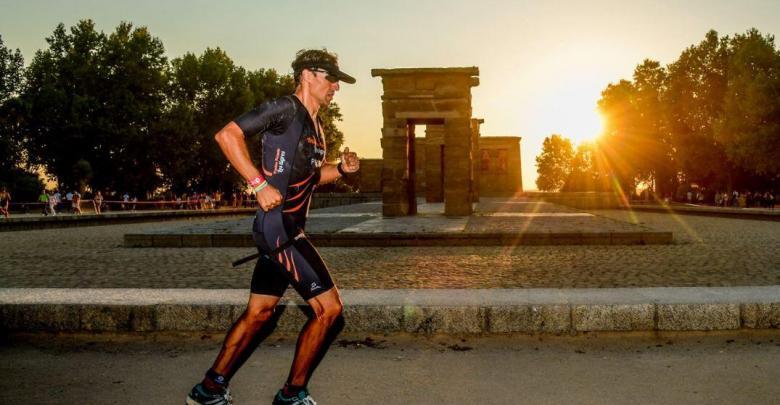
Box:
[0,210,780,288]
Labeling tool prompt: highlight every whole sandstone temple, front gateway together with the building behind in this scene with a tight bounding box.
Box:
[359,67,523,217]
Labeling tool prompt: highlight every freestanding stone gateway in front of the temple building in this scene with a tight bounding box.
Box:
[371,67,479,217]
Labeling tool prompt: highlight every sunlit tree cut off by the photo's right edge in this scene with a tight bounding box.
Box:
[714,29,780,178]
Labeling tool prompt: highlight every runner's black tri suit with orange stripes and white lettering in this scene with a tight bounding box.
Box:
[235,95,333,300]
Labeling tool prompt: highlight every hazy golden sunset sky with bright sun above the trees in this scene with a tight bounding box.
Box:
[0,0,780,189]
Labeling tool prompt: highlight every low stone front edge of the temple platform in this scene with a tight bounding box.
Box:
[124,231,674,247]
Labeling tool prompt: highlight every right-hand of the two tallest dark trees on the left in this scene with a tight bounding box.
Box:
[95,22,167,194]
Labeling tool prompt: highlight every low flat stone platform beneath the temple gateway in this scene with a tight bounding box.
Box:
[124,197,673,247]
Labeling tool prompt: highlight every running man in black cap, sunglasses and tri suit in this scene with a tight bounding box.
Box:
[187,49,360,405]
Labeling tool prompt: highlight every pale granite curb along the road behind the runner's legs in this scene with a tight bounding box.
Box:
[0,286,780,335]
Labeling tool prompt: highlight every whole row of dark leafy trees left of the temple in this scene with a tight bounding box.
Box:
[0,20,343,195]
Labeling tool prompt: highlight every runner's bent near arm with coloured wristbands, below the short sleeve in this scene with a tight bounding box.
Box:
[214,122,282,211]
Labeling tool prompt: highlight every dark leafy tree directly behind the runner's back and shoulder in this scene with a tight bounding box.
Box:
[158,48,260,193]
